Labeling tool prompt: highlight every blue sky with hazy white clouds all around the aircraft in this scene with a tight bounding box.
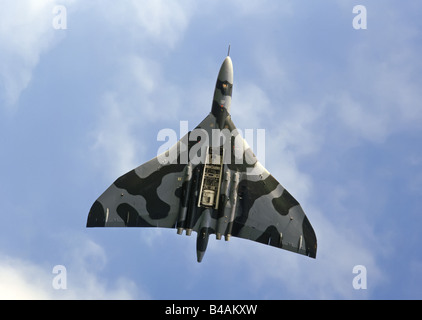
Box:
[0,0,422,299]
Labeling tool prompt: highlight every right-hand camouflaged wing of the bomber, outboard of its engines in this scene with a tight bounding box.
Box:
[232,168,317,258]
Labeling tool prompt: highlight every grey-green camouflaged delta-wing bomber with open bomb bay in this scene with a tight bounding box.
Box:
[86,48,317,262]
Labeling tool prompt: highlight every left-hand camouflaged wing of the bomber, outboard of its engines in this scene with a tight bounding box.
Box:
[87,137,186,228]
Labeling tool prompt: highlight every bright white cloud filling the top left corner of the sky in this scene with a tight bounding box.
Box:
[0,0,68,107]
